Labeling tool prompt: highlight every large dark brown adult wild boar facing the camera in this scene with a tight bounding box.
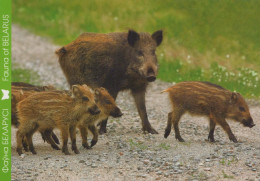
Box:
[56,30,163,134]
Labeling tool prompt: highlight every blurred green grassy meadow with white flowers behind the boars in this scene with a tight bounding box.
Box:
[12,0,260,98]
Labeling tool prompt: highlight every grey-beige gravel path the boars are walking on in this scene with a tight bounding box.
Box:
[12,25,260,181]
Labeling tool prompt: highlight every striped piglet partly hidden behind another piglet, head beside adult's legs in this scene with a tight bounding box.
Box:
[78,88,123,149]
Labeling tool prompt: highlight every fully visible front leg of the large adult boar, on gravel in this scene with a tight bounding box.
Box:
[132,89,158,134]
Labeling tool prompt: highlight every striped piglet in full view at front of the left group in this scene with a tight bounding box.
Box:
[16,85,100,155]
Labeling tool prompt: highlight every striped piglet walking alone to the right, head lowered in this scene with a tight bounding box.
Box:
[162,82,255,142]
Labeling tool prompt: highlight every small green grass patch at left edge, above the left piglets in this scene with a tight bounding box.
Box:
[12,68,40,84]
